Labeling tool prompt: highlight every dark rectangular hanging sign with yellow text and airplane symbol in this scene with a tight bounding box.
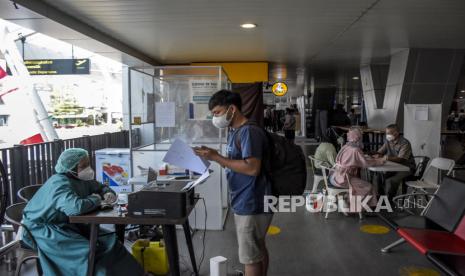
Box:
[24,58,90,76]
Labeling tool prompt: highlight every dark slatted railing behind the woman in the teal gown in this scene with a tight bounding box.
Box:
[0,131,129,204]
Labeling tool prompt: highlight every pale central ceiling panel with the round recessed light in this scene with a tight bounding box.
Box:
[37,0,373,64]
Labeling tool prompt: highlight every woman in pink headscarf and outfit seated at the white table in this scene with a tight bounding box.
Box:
[330,128,385,211]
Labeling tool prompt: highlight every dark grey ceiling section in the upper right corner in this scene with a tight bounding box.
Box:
[313,0,465,64]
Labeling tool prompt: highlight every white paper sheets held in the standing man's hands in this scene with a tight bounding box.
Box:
[163,139,210,174]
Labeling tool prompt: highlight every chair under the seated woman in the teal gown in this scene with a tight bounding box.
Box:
[5,202,42,276]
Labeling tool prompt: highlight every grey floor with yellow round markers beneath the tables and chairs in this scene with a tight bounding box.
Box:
[0,139,454,276]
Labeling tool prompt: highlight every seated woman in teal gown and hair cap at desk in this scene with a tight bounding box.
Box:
[23,148,144,275]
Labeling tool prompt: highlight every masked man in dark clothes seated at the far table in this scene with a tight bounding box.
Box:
[376,124,415,200]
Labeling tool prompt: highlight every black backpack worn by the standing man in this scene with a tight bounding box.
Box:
[235,122,307,196]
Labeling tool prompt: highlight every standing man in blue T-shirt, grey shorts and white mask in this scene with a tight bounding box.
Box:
[195,90,273,276]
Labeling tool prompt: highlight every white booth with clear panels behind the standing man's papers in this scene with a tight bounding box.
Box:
[128,66,231,230]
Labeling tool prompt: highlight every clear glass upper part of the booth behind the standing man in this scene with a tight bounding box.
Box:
[129,66,231,153]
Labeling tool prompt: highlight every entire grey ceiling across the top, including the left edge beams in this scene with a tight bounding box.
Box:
[0,0,465,87]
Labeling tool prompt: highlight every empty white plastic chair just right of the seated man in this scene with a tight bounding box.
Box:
[405,157,455,193]
